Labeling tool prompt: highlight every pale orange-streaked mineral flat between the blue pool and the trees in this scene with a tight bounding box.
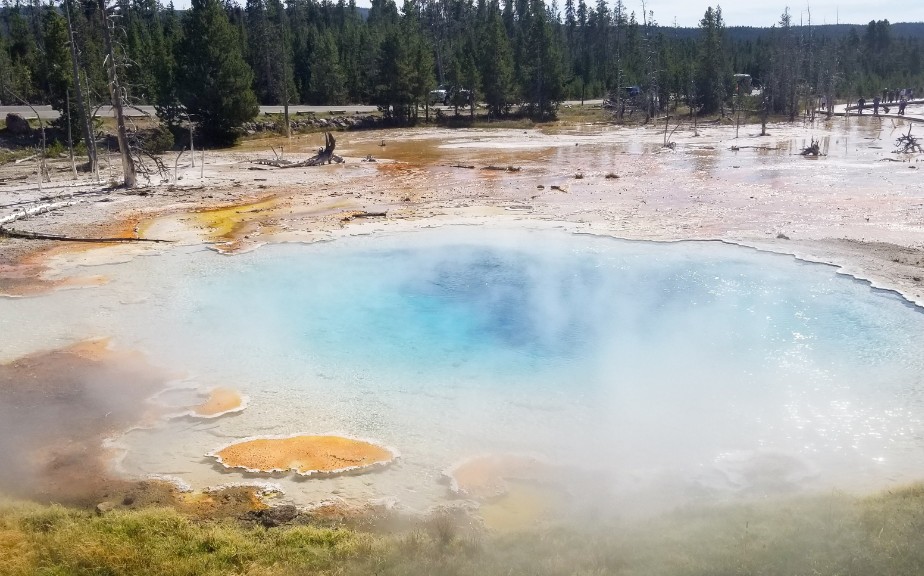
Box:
[0,118,924,512]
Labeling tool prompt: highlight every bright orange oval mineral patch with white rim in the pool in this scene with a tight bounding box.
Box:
[212,436,397,476]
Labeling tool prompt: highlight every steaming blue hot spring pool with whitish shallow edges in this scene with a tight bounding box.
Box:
[0,227,924,510]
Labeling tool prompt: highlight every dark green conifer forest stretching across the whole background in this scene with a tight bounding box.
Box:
[0,0,924,142]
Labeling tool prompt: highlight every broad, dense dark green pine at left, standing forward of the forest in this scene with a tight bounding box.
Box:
[177,0,259,144]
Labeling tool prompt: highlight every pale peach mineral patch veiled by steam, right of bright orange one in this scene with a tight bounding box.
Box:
[446,454,550,500]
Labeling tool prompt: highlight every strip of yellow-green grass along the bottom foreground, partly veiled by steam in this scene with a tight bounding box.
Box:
[0,486,924,576]
